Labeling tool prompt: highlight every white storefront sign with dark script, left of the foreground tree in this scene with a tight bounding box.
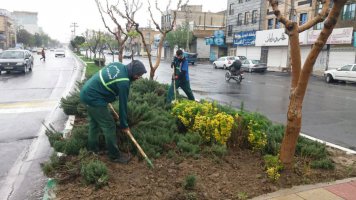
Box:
[256,28,288,46]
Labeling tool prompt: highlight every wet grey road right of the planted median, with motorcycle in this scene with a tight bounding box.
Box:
[124,58,356,150]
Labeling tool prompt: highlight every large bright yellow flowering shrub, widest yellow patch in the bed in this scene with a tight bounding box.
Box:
[172,100,238,144]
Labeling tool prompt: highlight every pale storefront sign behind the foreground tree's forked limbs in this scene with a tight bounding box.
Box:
[308,27,353,44]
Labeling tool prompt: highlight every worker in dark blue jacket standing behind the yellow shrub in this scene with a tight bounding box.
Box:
[166,49,195,103]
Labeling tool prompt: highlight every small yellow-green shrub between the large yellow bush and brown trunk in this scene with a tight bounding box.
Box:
[247,120,267,150]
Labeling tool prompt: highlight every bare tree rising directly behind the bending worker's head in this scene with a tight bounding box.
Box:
[95,0,142,62]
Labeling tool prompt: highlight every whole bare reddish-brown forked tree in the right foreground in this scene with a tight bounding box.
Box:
[268,0,347,170]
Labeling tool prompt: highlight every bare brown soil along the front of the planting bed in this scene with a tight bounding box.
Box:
[56,149,356,200]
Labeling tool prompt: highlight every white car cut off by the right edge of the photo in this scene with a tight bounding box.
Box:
[324,64,356,83]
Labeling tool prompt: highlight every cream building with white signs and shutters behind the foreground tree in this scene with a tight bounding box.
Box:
[254,0,356,75]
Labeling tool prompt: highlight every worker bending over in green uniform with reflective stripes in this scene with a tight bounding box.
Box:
[80,60,147,163]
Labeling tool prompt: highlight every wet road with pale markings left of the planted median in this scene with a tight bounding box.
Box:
[0,51,80,199]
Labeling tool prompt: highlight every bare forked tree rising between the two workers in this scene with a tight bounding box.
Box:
[124,0,189,80]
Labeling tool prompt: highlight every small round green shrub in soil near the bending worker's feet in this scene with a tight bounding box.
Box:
[80,160,109,188]
